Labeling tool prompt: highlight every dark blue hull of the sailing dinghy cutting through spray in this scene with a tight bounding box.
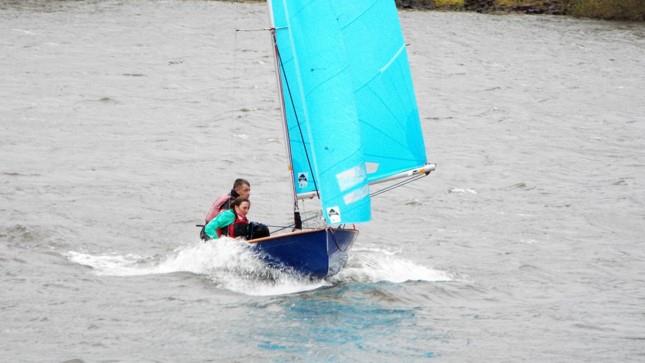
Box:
[249,228,358,278]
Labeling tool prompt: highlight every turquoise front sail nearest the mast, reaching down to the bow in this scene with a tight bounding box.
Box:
[269,0,371,224]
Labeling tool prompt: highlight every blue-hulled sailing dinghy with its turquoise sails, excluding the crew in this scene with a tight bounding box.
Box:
[244,0,435,278]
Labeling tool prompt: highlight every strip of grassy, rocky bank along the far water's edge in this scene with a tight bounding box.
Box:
[396,0,645,21]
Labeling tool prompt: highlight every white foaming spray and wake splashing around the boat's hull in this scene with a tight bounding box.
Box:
[66,237,452,296]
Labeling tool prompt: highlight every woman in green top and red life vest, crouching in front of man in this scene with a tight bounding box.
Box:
[204,197,251,239]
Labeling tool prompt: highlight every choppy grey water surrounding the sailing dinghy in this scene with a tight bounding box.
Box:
[0,1,645,362]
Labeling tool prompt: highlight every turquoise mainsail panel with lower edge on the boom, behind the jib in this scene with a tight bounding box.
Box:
[332,0,427,183]
